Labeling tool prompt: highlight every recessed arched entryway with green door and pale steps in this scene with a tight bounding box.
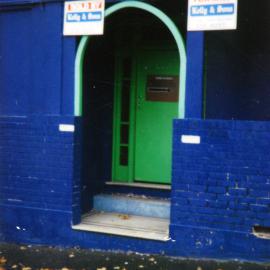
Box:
[73,1,185,241]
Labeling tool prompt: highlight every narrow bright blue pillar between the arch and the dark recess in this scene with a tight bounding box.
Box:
[185,32,204,119]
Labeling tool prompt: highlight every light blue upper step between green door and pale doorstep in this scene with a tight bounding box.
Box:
[93,194,170,219]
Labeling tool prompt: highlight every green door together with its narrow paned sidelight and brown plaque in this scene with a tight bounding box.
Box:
[113,49,179,184]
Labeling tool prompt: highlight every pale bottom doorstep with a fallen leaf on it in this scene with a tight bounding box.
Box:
[72,211,169,242]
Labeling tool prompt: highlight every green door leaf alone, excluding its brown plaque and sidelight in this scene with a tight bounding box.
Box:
[134,50,179,184]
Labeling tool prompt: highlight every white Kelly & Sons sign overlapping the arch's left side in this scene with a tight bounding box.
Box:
[64,0,105,36]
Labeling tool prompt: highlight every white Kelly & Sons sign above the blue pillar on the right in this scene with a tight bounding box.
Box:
[188,0,237,31]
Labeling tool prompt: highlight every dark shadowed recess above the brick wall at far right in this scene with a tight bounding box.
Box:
[205,0,270,120]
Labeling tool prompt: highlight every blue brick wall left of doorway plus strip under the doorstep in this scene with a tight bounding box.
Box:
[0,115,172,253]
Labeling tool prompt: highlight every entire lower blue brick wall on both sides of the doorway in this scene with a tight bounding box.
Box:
[0,116,270,261]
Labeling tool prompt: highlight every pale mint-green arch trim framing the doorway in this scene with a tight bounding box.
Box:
[74,1,187,119]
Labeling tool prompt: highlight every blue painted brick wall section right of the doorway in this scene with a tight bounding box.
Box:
[171,120,270,259]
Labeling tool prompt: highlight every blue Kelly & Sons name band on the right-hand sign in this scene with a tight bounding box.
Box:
[190,4,235,16]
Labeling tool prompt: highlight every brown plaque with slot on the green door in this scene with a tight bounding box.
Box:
[146,75,179,102]
